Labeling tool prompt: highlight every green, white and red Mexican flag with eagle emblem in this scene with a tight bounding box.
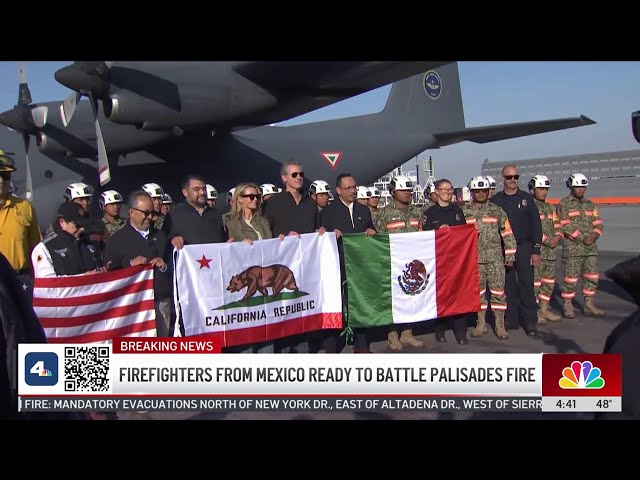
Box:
[343,225,480,327]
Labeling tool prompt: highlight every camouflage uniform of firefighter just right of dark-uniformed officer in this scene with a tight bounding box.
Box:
[533,200,563,323]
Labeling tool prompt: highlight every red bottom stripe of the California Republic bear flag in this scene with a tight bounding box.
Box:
[188,313,342,347]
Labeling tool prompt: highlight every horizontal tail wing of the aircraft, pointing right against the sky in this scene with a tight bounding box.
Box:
[434,115,596,146]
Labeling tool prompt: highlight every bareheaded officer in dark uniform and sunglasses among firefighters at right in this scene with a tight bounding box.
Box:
[491,165,542,338]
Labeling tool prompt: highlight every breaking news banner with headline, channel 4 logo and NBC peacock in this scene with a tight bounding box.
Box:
[18,338,622,412]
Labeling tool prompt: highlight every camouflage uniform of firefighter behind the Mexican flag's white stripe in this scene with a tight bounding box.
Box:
[372,201,424,351]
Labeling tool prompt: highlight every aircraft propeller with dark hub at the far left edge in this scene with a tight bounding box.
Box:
[0,63,49,199]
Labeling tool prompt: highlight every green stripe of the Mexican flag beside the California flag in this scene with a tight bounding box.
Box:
[342,234,393,328]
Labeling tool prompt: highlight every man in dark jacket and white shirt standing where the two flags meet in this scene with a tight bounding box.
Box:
[320,173,376,353]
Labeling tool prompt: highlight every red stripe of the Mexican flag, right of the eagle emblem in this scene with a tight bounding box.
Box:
[435,224,480,318]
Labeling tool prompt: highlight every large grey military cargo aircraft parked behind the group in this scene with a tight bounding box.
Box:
[0,62,595,227]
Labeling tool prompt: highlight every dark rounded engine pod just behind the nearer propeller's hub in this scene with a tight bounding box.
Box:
[103,92,180,126]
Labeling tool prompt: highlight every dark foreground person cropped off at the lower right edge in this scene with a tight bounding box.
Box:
[596,256,640,420]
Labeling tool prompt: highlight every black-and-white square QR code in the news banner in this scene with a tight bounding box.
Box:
[64,347,109,392]
